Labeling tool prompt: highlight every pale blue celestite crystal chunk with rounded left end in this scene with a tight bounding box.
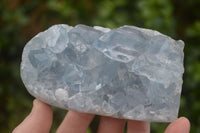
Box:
[21,24,184,122]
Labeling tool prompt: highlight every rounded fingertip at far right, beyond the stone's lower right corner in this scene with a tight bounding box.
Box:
[165,117,190,133]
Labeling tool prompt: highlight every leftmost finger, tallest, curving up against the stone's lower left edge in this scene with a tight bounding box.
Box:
[13,99,53,133]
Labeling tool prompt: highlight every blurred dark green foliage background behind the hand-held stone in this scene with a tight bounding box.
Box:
[0,0,200,133]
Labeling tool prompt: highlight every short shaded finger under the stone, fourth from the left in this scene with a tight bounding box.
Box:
[127,120,150,133]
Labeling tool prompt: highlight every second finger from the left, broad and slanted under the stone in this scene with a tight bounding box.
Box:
[57,111,94,133]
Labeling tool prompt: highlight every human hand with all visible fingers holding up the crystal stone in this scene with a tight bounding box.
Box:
[13,99,190,133]
